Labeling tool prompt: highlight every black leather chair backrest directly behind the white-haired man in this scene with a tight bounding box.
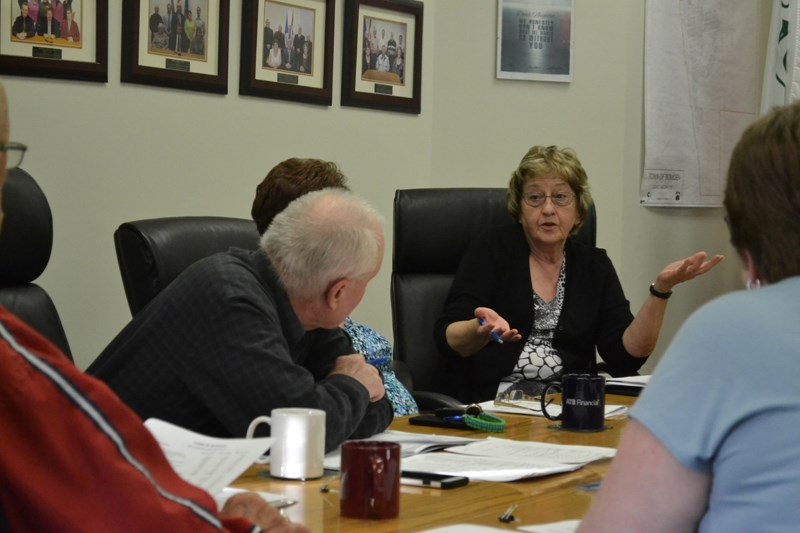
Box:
[114,216,259,315]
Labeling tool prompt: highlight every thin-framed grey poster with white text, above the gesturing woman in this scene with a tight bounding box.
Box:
[497,0,575,82]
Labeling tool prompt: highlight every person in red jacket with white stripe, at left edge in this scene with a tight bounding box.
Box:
[0,84,308,533]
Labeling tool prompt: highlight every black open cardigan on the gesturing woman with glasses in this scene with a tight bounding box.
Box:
[434,222,646,402]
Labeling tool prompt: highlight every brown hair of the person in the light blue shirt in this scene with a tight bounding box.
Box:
[724,103,800,283]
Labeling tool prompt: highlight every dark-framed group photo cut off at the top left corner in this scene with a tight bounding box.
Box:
[0,0,108,83]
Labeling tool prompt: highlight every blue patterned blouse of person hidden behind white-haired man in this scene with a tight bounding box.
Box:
[344,317,419,416]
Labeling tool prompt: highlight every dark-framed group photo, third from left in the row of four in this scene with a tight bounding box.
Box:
[239,0,336,106]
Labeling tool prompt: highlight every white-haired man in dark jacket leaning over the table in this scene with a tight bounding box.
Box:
[88,189,392,451]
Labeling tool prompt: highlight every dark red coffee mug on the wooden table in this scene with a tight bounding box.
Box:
[339,441,400,519]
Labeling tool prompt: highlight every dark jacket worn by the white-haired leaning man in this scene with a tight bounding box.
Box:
[88,254,391,451]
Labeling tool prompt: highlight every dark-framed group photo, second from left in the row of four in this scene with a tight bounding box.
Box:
[120,0,230,94]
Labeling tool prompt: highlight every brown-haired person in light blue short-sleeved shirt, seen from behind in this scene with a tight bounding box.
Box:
[579,102,800,533]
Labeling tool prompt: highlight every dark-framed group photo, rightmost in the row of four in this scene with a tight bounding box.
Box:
[341,0,423,114]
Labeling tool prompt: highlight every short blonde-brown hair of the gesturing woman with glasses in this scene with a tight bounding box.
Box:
[506,145,592,235]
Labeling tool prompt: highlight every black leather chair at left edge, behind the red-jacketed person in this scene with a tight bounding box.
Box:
[0,168,72,360]
